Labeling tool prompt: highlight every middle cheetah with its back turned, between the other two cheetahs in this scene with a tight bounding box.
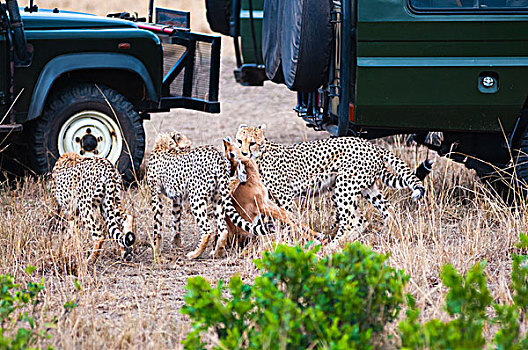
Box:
[147,132,266,259]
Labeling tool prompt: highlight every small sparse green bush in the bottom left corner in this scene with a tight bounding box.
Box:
[0,266,80,350]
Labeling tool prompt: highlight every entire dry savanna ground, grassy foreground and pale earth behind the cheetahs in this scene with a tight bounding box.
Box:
[0,0,528,349]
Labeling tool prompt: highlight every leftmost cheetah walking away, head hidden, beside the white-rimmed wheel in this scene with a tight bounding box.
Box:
[51,152,136,262]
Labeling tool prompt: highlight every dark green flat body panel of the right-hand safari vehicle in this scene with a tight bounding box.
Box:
[354,0,528,132]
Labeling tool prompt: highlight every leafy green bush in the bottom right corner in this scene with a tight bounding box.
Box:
[399,235,528,350]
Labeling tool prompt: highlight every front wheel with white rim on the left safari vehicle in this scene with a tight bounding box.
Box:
[29,84,145,183]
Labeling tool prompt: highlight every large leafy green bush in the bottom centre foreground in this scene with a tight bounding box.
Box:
[181,243,408,349]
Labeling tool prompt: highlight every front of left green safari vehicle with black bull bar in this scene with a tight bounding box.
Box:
[0,0,220,181]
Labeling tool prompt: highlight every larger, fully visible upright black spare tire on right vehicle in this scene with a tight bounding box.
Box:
[280,0,333,92]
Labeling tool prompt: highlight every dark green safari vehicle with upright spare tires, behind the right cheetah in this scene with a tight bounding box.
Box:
[206,0,528,197]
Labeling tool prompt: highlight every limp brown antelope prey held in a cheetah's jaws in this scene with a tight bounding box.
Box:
[223,137,319,242]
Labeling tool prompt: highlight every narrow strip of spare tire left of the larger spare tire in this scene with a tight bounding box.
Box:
[262,0,284,83]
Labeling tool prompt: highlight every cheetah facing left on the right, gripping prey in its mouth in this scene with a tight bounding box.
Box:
[236,124,425,241]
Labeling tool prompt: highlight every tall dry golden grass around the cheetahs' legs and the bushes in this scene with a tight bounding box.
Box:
[0,139,528,349]
